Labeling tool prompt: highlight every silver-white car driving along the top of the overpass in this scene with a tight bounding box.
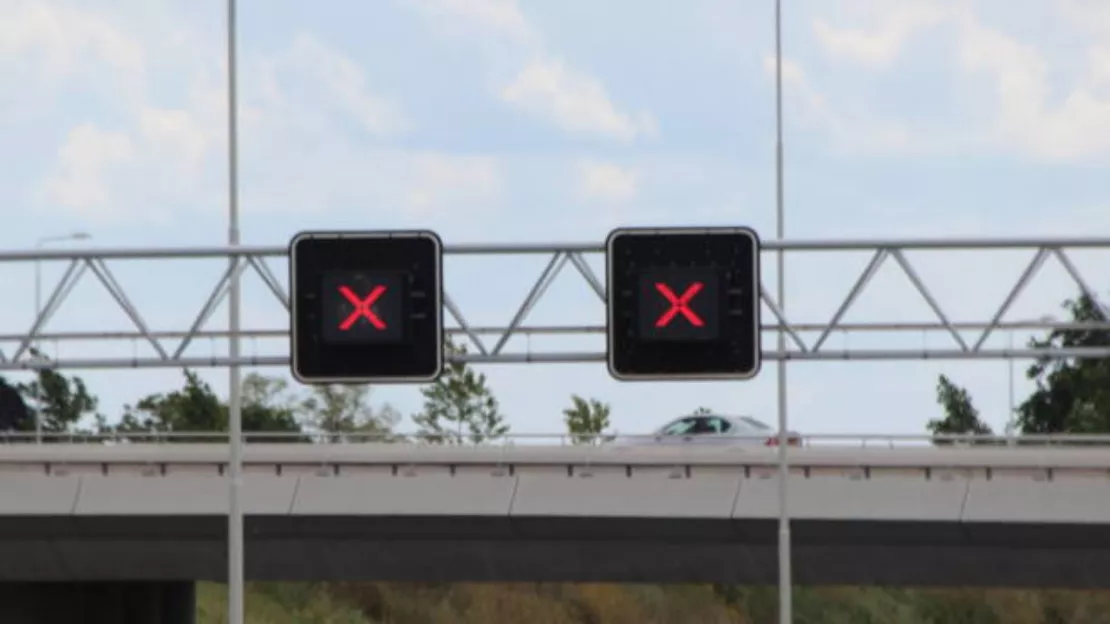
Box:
[614,414,801,446]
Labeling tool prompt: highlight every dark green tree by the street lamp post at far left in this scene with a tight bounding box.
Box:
[16,349,102,433]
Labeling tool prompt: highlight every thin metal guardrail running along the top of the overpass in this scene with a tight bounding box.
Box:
[0,431,1110,449]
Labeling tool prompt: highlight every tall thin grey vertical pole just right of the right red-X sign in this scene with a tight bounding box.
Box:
[775,0,794,624]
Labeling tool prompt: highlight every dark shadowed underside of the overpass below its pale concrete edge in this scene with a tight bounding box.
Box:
[0,516,1110,586]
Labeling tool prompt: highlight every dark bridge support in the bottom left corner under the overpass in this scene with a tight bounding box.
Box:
[0,581,196,624]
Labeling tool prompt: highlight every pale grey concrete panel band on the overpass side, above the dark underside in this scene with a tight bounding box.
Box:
[0,467,1110,525]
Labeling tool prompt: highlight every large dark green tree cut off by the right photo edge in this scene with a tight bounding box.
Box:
[1017,294,1110,434]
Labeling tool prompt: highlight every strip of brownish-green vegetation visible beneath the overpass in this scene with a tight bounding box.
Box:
[196,583,1110,624]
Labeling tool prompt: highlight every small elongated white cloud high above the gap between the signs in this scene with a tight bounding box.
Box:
[501,60,657,141]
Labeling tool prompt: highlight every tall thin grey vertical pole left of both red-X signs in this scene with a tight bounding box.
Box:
[228,0,244,624]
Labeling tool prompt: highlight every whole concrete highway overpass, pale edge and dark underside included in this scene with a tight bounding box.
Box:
[0,444,1110,587]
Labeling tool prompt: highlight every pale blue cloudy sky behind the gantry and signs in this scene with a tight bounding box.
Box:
[0,0,1110,434]
